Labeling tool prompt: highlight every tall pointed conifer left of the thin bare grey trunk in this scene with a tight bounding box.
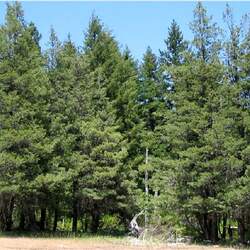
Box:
[72,16,138,232]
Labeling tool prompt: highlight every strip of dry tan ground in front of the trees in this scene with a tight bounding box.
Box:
[0,237,243,250]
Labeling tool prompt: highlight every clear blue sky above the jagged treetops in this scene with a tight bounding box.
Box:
[0,1,250,59]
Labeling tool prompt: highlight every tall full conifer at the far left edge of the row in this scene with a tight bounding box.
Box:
[0,2,50,230]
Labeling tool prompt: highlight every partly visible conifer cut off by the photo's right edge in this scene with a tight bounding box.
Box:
[225,21,250,243]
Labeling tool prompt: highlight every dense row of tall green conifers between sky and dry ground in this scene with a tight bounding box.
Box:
[0,2,250,243]
